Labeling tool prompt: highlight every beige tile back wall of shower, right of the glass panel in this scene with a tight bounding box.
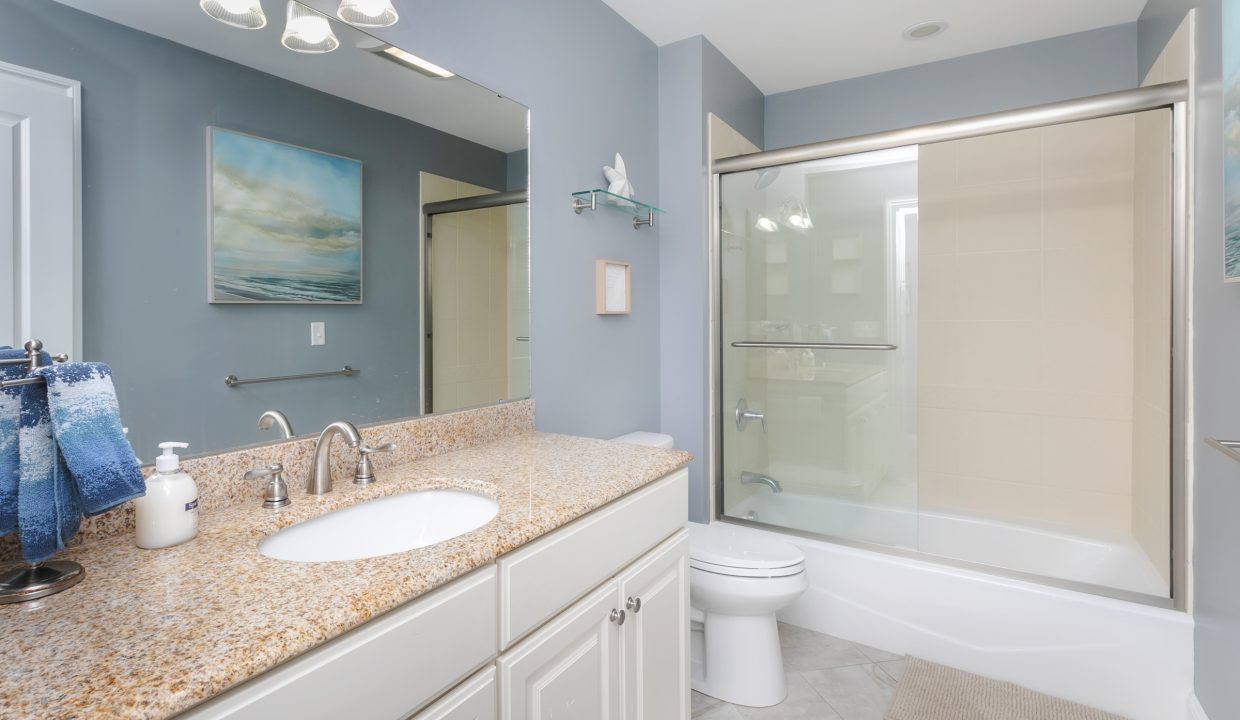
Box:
[918,118,1133,533]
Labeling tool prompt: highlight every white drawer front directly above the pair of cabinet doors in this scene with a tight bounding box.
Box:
[498,470,688,649]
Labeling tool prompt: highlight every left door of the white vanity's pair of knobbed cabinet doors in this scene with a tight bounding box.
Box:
[497,581,621,720]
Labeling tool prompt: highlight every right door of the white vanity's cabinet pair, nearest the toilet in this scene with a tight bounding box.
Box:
[618,530,689,720]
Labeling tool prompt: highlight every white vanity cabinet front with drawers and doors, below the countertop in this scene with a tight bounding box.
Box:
[182,470,689,720]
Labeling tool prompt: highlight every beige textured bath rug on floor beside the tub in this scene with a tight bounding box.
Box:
[887,657,1125,720]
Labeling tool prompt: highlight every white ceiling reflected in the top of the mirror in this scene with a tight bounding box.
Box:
[50,0,528,152]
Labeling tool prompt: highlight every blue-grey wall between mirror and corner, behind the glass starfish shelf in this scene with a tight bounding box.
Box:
[344,0,664,437]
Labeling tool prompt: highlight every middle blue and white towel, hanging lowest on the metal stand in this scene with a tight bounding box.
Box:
[17,353,82,563]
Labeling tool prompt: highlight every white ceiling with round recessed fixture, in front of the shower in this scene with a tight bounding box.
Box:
[604,0,1146,94]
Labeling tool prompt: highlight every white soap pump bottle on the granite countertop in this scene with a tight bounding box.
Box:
[134,442,198,548]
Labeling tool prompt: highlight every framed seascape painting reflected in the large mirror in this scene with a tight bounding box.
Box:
[208,128,362,304]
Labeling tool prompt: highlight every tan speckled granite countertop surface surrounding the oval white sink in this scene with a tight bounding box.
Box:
[0,432,689,719]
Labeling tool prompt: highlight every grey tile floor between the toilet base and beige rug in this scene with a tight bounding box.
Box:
[693,622,904,720]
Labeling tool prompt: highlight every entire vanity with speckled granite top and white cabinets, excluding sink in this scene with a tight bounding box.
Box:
[0,426,689,720]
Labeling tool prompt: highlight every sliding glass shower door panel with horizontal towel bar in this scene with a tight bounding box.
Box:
[719,147,918,548]
